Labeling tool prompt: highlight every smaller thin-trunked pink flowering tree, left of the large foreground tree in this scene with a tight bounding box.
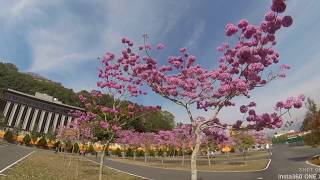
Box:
[79,91,159,180]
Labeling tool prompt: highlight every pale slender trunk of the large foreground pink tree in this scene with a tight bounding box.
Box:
[191,125,201,180]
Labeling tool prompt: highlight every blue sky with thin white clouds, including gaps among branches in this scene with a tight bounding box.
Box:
[0,0,320,129]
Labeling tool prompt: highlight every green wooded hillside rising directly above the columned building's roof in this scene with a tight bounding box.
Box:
[0,63,82,107]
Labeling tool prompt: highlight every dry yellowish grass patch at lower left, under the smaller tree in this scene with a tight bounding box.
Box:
[0,150,140,180]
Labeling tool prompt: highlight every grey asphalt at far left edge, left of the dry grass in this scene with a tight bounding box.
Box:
[0,144,33,172]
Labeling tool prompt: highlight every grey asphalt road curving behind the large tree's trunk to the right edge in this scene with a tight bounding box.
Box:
[90,145,320,180]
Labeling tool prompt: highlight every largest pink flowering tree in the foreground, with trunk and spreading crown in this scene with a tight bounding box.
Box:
[100,0,304,180]
